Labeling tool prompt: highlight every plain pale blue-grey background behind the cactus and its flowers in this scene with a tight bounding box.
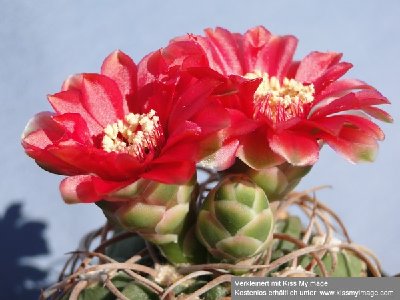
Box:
[0,0,400,296]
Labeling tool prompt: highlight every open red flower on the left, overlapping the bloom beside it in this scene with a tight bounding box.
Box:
[22,51,229,202]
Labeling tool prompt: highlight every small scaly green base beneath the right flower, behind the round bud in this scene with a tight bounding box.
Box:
[246,163,311,201]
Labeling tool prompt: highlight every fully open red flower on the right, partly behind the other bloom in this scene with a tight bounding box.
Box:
[147,26,392,169]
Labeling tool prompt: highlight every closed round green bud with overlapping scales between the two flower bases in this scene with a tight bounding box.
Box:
[196,175,273,262]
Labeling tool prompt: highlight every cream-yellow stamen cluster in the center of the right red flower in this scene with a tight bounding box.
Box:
[244,71,315,123]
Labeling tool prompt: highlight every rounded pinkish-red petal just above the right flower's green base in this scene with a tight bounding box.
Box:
[269,130,319,166]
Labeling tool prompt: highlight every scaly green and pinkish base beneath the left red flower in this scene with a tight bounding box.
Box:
[98,179,204,263]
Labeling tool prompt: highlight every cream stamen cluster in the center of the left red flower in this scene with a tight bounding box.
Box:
[102,110,164,161]
